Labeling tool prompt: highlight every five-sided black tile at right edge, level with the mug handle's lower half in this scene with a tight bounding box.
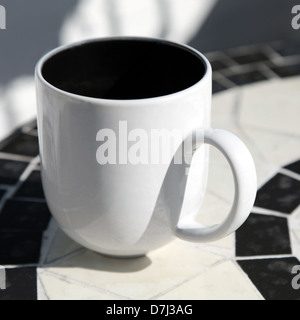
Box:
[255,174,300,213]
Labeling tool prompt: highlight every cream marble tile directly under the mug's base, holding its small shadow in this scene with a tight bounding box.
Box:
[46,240,222,299]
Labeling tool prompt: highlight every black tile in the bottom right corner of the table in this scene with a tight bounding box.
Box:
[238,258,300,300]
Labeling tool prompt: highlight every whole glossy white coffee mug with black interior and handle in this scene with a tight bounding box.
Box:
[36,37,256,257]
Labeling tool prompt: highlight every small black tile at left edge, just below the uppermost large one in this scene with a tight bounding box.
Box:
[0,159,28,185]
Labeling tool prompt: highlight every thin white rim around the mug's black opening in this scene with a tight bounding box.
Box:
[35,36,212,105]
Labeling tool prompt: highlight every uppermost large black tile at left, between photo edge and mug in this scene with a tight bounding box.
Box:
[0,133,39,157]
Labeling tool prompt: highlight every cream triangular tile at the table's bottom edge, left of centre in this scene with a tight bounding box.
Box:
[38,271,119,300]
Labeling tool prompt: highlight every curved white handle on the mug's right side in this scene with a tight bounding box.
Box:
[175,129,257,242]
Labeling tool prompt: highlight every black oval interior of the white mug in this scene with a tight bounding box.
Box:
[42,39,206,100]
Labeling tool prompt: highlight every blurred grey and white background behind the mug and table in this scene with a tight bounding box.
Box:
[0,0,300,139]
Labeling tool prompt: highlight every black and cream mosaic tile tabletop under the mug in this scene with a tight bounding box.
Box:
[0,43,300,300]
